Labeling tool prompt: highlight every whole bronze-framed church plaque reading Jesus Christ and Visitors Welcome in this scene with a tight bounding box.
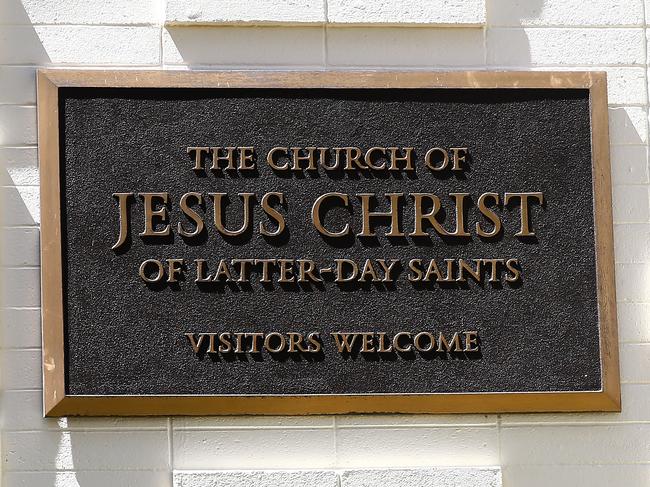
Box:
[38,70,620,416]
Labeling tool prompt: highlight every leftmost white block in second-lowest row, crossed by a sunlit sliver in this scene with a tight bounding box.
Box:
[2,431,169,470]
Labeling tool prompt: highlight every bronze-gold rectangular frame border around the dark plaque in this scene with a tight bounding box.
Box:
[37,69,621,416]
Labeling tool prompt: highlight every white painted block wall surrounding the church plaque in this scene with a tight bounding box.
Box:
[0,0,650,487]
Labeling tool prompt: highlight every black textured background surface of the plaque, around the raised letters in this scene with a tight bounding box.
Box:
[60,88,601,395]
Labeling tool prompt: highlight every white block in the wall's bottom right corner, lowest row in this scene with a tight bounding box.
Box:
[503,465,650,487]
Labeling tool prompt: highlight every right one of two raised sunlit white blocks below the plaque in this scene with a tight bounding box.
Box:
[341,467,501,487]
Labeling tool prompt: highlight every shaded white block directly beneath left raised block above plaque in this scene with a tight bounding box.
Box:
[163,27,324,66]
